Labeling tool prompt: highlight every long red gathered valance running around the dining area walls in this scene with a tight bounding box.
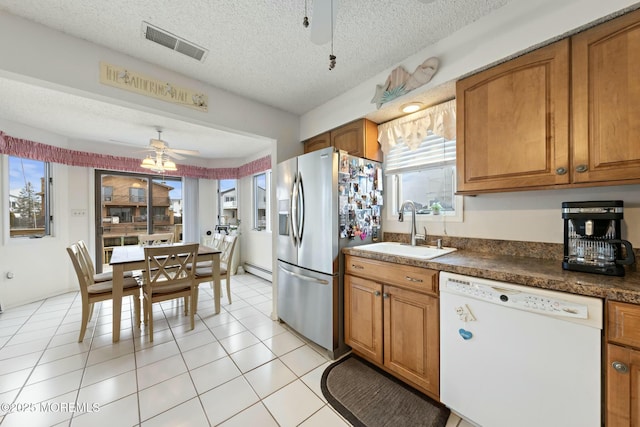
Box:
[0,131,271,179]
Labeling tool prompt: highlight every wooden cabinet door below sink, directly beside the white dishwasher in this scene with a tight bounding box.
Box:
[383,285,440,396]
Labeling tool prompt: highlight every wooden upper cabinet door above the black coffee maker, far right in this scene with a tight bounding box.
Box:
[571,11,640,183]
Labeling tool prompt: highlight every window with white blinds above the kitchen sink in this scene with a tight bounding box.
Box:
[385,132,462,220]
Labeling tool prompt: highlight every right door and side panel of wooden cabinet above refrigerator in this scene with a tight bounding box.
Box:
[331,119,382,162]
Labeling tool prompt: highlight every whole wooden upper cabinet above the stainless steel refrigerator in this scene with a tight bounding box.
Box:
[304,119,382,162]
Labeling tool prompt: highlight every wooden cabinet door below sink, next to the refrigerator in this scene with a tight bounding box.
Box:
[344,274,383,364]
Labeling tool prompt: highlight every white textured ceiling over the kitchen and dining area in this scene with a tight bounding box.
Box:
[0,0,509,157]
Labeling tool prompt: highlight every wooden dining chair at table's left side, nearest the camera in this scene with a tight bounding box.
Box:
[67,243,140,342]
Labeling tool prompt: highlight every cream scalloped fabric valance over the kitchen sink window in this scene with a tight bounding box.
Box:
[378,99,456,154]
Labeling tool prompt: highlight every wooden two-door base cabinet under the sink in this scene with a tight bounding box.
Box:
[344,257,440,400]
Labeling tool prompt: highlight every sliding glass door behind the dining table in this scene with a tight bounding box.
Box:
[95,170,183,271]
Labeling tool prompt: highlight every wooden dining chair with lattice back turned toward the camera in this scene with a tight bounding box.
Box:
[142,243,198,342]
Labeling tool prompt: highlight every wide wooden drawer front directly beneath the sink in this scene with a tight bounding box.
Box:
[345,255,438,295]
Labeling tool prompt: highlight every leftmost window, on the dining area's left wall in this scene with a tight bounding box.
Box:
[9,156,53,237]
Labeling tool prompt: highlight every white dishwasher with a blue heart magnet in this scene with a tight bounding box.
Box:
[440,272,602,427]
